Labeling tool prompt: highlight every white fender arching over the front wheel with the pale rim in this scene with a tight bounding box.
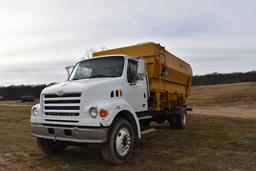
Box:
[90,99,141,138]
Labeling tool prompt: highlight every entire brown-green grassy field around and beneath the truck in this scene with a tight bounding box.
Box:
[0,83,256,171]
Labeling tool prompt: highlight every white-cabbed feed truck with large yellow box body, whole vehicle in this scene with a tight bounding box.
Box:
[31,42,192,164]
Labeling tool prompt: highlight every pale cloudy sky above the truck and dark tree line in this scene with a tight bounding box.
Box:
[0,0,256,86]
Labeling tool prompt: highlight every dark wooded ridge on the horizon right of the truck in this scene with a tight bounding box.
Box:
[192,71,256,86]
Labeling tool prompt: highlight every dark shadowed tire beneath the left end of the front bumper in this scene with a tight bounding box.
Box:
[37,138,67,154]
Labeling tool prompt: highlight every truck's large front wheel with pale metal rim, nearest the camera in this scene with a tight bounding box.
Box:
[102,119,134,165]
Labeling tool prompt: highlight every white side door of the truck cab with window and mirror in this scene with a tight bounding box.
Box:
[124,58,148,112]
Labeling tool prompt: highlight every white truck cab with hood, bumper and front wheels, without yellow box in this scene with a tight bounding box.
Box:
[31,55,149,164]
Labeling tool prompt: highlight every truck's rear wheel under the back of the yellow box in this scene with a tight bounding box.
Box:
[168,107,187,129]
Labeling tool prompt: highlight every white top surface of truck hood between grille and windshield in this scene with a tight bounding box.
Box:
[42,78,120,94]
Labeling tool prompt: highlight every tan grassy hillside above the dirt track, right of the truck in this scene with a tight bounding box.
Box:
[188,82,256,106]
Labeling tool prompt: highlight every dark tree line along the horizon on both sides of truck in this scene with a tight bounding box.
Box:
[0,71,256,100]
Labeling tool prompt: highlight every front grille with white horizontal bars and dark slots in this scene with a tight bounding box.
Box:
[43,93,81,117]
